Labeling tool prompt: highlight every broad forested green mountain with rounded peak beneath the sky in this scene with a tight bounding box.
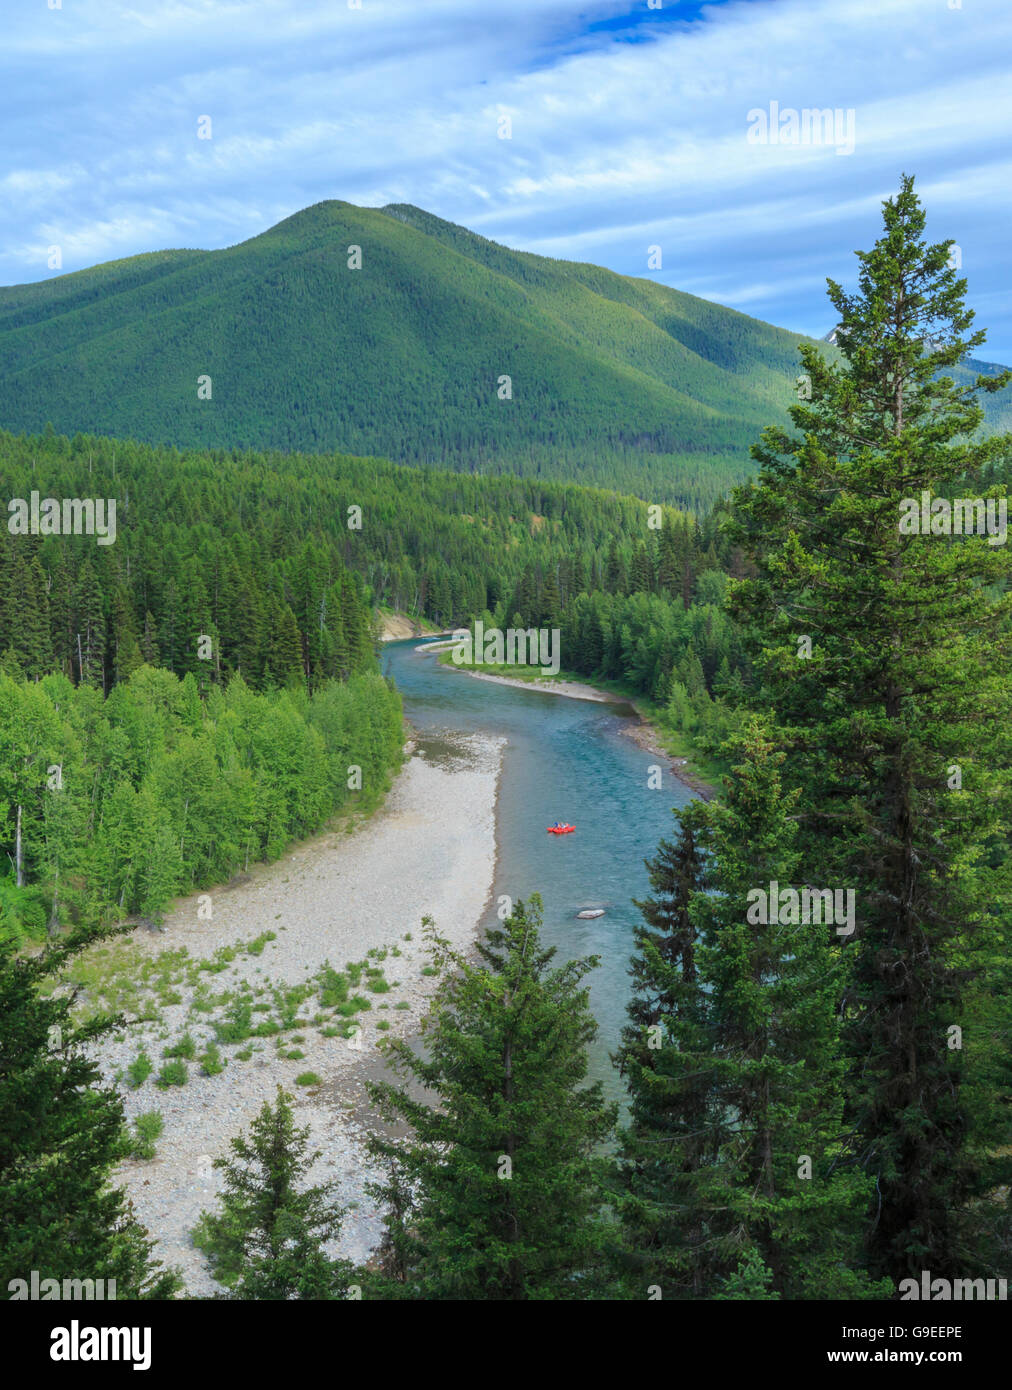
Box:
[0,202,1006,509]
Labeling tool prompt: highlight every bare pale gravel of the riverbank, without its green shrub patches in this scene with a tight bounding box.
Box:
[91,734,503,1297]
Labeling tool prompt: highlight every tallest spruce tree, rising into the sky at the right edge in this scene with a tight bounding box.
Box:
[730,178,1012,1280]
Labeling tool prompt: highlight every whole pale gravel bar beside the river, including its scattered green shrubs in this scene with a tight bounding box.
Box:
[83,734,503,1297]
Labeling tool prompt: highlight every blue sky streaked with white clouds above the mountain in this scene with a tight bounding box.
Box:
[0,0,1012,363]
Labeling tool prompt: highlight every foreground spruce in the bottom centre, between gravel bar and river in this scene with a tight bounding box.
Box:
[368,894,614,1301]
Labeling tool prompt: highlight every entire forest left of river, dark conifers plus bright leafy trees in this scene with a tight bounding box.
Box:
[0,431,691,935]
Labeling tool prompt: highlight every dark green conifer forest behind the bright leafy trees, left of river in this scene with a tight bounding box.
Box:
[0,432,667,691]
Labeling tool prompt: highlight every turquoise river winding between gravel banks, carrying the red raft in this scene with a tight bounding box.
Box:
[384,638,691,1098]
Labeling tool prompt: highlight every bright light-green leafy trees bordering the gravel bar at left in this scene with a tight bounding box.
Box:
[0,666,402,938]
